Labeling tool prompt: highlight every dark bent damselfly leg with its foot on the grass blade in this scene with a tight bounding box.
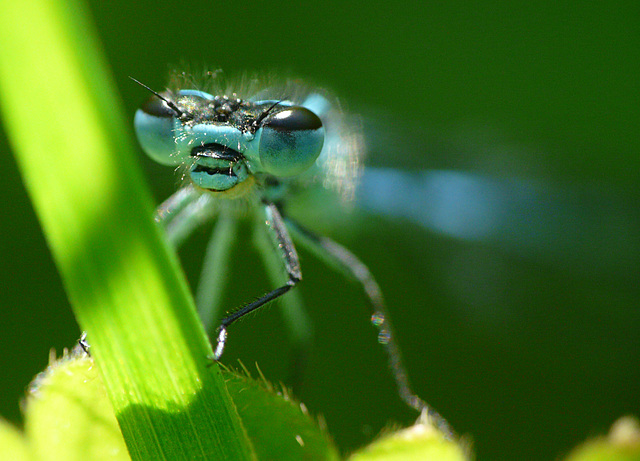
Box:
[212,202,302,360]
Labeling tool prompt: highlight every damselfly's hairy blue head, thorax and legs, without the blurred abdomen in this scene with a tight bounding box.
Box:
[135,74,448,432]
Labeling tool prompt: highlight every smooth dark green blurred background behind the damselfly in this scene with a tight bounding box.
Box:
[0,0,640,460]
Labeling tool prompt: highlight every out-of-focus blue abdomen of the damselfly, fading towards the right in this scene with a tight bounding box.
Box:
[357,168,640,271]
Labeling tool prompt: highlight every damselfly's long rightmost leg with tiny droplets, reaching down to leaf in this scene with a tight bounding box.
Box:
[285,218,453,435]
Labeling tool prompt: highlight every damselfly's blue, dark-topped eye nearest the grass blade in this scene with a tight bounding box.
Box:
[133,96,181,165]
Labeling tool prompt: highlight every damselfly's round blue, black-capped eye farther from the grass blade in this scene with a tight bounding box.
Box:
[259,106,324,176]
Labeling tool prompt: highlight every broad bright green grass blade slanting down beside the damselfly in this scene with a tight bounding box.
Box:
[0,0,253,459]
